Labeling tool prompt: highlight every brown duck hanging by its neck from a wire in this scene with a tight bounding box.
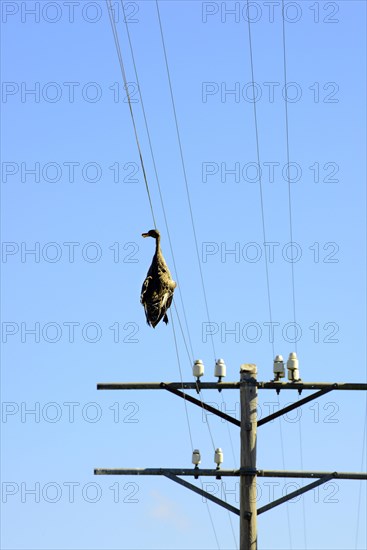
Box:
[140,229,177,328]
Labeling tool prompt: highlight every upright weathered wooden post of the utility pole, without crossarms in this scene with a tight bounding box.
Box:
[240,364,257,550]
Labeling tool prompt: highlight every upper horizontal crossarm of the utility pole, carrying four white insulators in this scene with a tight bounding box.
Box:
[97,382,367,391]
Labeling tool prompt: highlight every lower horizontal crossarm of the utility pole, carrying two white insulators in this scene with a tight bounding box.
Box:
[94,468,367,480]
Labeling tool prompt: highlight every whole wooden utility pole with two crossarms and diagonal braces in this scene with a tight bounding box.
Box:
[94,374,367,550]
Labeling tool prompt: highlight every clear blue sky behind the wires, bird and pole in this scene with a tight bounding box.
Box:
[1,0,367,550]
